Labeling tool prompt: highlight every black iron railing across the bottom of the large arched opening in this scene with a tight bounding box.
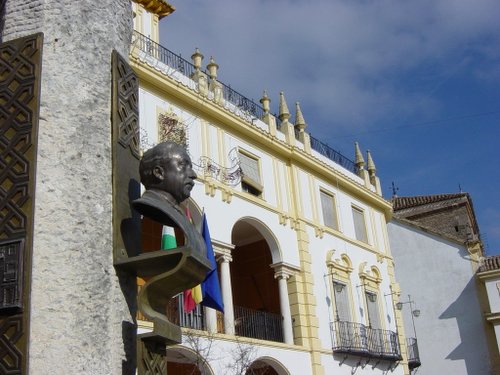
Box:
[234,306,283,342]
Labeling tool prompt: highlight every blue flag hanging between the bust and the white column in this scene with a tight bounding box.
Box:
[201,214,224,312]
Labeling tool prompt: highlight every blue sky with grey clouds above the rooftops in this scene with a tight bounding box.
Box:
[160,0,500,255]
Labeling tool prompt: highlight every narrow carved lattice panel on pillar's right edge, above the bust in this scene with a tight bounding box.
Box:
[113,53,140,159]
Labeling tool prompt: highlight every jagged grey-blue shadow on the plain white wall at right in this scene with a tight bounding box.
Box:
[439,278,491,375]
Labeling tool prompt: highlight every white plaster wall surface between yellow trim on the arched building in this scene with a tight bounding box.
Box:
[140,85,402,375]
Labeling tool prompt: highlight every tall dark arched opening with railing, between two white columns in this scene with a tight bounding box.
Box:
[231,219,283,342]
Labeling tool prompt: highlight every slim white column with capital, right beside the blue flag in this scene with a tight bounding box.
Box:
[212,240,235,335]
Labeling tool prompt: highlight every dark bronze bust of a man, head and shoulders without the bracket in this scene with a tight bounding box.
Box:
[132,141,206,255]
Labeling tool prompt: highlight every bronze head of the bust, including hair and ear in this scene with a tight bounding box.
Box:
[139,141,196,203]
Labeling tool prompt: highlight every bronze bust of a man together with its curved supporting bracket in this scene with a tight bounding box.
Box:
[126,142,210,351]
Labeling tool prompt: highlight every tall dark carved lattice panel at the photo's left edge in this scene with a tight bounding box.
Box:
[0,34,43,375]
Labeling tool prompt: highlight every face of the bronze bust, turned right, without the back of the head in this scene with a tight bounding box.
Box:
[153,147,196,203]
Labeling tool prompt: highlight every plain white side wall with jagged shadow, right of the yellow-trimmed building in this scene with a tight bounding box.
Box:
[388,220,490,375]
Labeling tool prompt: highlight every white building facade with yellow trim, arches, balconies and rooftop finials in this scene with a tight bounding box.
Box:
[130,1,409,375]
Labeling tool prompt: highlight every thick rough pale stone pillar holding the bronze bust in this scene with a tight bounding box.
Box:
[0,0,136,375]
